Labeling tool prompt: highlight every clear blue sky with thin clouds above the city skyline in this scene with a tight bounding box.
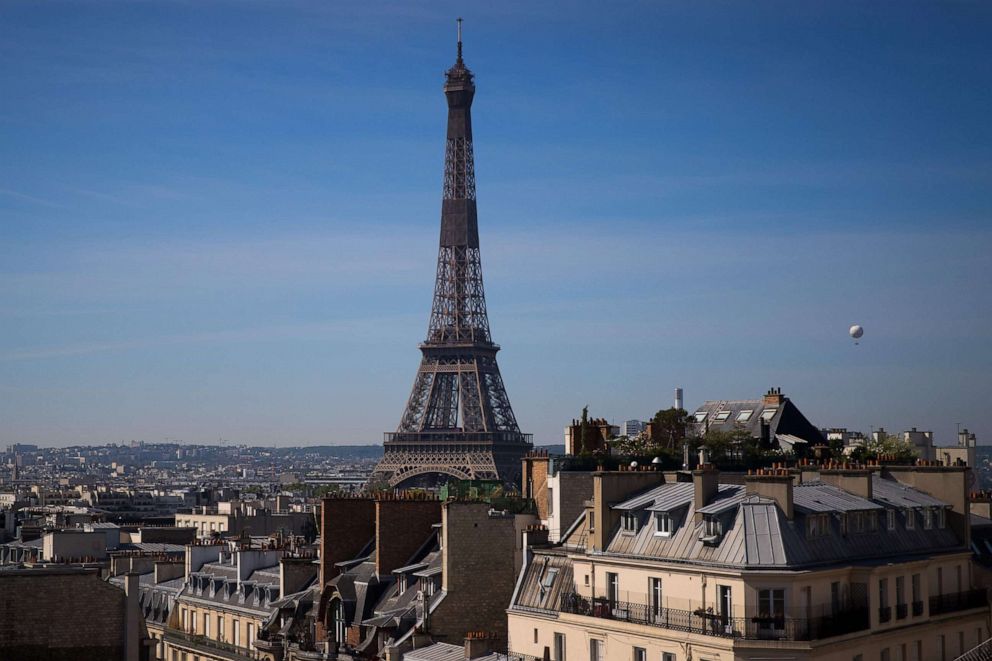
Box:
[0,0,992,445]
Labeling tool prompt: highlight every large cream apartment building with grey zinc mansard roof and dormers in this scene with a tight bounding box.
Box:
[508,461,990,661]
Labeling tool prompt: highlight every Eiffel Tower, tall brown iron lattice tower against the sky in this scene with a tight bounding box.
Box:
[370,19,533,487]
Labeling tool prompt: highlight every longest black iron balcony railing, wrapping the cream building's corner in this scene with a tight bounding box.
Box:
[559,593,870,640]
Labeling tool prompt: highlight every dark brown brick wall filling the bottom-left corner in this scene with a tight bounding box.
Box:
[0,570,125,661]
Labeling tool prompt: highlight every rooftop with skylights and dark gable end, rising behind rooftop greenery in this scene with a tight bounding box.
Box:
[692,388,824,454]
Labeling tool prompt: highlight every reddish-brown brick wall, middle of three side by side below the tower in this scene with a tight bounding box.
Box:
[375,497,441,575]
